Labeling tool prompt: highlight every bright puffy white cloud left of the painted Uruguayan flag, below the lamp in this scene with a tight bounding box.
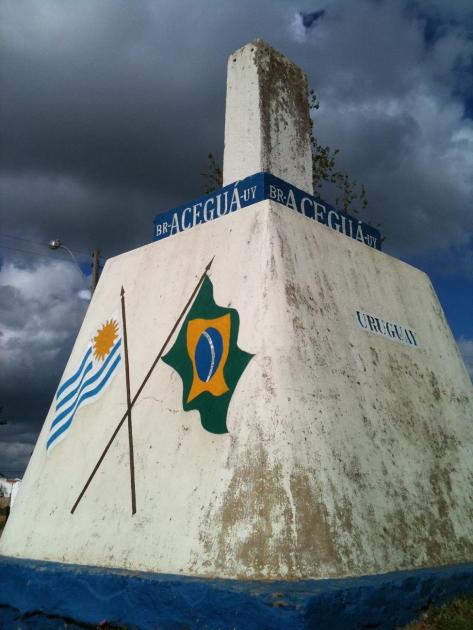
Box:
[0,262,86,398]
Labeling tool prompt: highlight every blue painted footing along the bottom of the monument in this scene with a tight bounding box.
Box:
[0,556,473,630]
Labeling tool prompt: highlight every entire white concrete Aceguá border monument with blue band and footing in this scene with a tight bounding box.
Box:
[0,40,473,628]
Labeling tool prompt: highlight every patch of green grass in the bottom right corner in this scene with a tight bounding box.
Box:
[405,596,473,630]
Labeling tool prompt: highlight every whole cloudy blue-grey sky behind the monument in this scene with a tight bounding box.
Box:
[0,0,473,474]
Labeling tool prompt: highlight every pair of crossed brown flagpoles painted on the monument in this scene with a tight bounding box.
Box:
[71,257,214,514]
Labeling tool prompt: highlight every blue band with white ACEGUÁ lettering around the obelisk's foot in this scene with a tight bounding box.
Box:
[153,173,381,250]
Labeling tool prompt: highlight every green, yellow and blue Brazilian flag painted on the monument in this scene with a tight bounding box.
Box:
[163,276,253,433]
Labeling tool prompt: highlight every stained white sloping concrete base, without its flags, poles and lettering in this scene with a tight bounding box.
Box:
[0,201,473,578]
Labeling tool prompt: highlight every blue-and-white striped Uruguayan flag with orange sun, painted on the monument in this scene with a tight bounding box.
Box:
[46,314,122,452]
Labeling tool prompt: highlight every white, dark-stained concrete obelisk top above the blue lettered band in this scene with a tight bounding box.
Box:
[223,39,313,193]
